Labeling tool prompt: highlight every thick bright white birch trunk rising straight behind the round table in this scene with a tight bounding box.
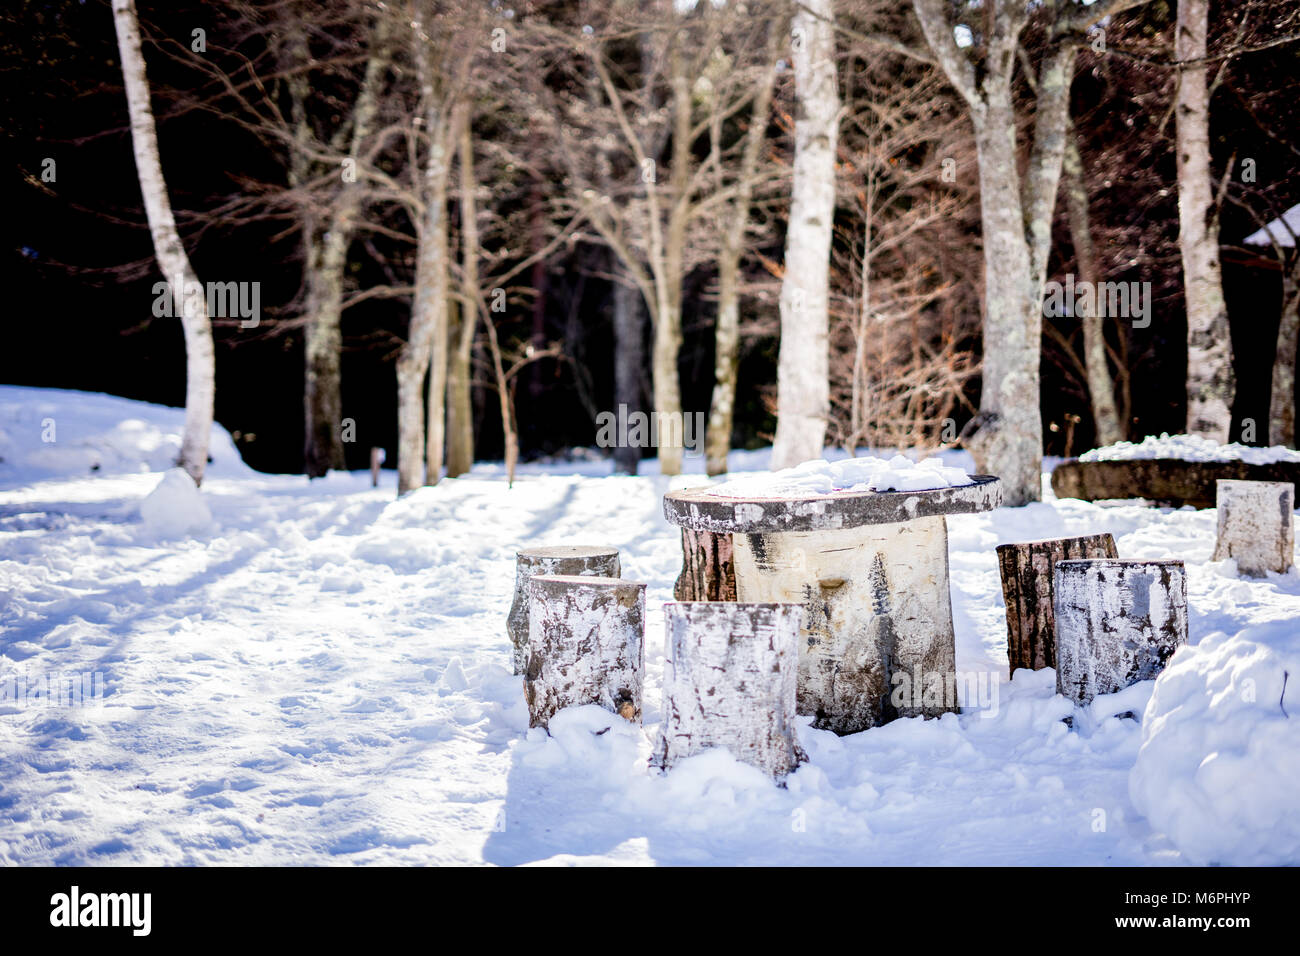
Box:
[771,0,840,468]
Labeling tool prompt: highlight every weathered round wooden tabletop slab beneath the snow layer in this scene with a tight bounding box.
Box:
[663,475,1002,535]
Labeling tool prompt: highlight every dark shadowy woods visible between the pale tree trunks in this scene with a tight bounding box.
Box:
[0,0,1300,472]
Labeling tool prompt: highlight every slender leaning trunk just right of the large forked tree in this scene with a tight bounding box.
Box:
[1065,129,1125,446]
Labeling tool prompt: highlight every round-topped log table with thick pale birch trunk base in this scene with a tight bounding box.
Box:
[663,475,1002,734]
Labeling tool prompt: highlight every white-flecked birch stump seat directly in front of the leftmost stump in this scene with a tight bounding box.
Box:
[524,575,646,727]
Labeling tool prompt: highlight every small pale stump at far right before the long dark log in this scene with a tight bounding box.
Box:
[1214,480,1296,578]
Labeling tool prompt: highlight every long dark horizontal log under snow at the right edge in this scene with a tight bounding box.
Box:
[1052,458,1300,507]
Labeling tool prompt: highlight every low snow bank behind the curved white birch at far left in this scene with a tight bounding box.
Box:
[0,385,252,484]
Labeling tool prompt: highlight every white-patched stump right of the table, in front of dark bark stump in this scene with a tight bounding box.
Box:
[1054,558,1187,704]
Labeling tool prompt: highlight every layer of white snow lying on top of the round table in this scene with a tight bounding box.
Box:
[709,455,972,498]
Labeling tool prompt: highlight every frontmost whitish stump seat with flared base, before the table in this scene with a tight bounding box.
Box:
[653,602,806,779]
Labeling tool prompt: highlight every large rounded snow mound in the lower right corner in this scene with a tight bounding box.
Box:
[1128,620,1300,866]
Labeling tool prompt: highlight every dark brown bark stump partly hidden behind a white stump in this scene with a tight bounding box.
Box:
[997,535,1119,675]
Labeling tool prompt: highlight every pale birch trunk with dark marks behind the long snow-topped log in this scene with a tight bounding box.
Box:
[1174,0,1236,442]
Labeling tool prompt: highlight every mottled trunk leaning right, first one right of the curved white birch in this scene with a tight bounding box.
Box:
[303,17,390,486]
